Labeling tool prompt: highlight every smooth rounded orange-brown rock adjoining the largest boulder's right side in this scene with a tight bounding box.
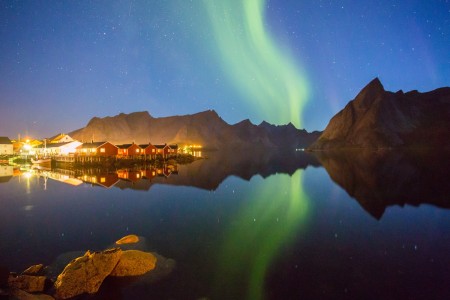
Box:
[110,250,156,277]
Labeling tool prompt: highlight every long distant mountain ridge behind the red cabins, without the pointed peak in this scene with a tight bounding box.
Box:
[69,110,320,149]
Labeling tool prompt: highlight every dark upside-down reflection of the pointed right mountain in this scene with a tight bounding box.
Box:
[317,150,450,219]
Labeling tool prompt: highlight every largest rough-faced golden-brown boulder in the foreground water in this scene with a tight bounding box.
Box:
[55,248,122,299]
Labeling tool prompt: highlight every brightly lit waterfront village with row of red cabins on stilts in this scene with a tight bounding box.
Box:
[0,133,201,164]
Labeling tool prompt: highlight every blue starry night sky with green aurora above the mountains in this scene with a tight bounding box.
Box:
[0,0,450,138]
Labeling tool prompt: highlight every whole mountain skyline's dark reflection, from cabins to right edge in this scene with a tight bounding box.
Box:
[23,150,450,219]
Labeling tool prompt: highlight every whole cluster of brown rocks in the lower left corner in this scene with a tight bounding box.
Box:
[0,235,175,300]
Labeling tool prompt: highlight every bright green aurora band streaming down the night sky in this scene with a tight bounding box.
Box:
[203,0,308,128]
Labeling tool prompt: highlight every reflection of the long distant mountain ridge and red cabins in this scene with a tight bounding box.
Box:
[26,151,320,191]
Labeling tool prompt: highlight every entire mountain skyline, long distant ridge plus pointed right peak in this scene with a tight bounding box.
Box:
[70,78,450,151]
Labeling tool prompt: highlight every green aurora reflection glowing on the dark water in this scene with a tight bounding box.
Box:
[216,170,309,299]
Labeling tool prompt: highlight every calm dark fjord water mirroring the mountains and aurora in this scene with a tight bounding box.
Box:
[0,152,450,299]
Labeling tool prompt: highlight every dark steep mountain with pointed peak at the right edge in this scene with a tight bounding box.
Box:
[308,78,450,150]
